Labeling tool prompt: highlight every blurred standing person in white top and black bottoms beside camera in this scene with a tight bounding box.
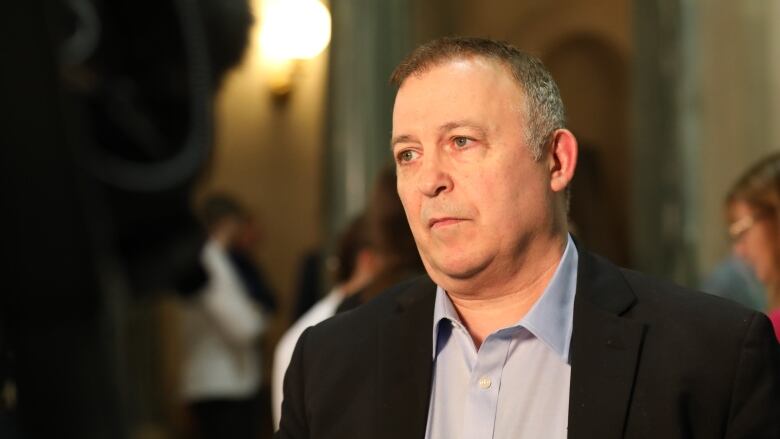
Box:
[182,195,274,439]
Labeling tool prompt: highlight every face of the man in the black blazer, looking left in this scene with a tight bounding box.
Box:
[393,57,555,288]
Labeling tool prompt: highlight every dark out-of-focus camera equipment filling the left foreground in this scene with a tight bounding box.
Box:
[0,0,252,438]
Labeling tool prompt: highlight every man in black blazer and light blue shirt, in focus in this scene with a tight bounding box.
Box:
[279,38,780,439]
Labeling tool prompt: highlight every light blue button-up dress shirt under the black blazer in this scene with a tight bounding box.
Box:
[425,236,578,439]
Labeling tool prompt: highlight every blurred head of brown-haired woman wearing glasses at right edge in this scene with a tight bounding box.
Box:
[726,153,780,340]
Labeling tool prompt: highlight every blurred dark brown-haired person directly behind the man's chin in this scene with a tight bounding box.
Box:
[338,166,425,312]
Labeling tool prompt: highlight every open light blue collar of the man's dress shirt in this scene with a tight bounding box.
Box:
[433,235,579,363]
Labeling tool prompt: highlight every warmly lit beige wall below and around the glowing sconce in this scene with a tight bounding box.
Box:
[198,2,327,326]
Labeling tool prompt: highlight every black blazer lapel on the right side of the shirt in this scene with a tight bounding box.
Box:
[569,251,645,439]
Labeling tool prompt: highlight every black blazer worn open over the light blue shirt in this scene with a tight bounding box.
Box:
[276,251,780,439]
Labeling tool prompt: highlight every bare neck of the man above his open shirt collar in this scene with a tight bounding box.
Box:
[447,234,568,349]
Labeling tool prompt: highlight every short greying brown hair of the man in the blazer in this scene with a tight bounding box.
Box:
[390,37,566,161]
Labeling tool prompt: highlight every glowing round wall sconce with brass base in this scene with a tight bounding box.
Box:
[260,0,331,96]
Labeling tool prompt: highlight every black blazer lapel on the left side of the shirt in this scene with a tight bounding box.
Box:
[376,276,436,439]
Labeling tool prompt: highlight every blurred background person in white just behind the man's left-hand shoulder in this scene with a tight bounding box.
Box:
[271,215,379,428]
